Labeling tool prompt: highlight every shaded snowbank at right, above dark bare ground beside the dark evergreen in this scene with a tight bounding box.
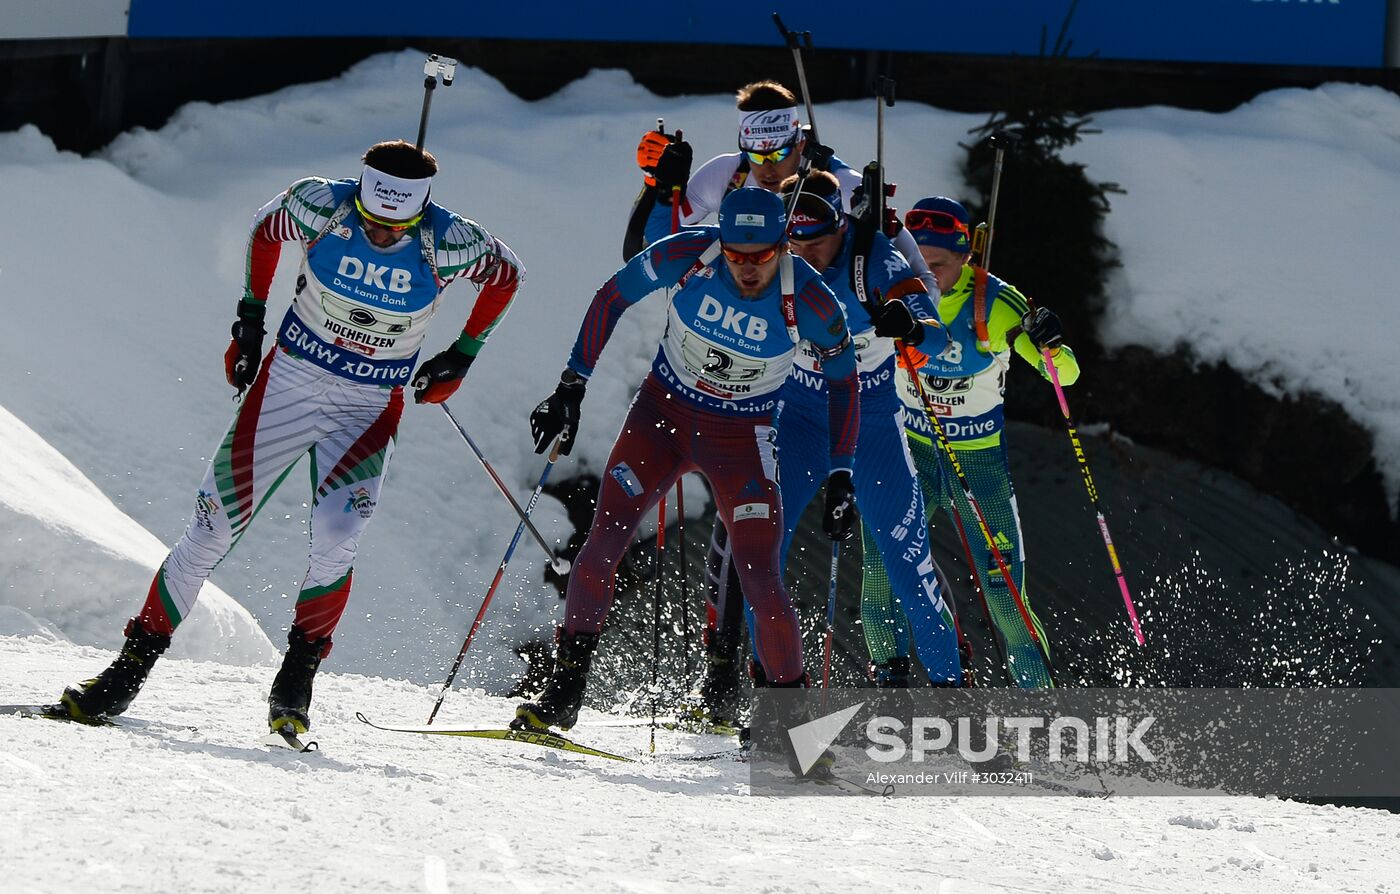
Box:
[1065,84,1400,509]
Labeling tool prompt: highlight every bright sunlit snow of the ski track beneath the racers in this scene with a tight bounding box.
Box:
[0,637,1400,894]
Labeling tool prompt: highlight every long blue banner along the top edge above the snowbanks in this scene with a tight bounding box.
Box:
[127,0,1387,69]
